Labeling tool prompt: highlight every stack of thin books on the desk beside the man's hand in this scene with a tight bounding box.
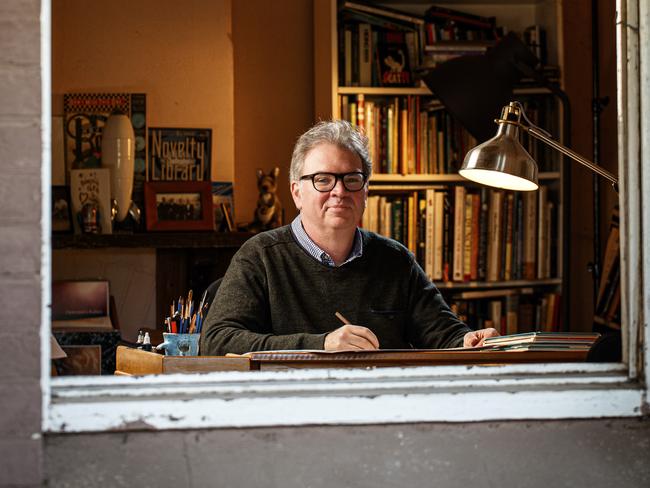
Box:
[484,332,600,351]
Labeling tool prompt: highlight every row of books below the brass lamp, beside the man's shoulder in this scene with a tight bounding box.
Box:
[362,185,557,282]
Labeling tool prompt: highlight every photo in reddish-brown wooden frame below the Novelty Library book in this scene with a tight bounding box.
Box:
[144,181,214,231]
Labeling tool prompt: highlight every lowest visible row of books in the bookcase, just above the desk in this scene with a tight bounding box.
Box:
[449,288,562,335]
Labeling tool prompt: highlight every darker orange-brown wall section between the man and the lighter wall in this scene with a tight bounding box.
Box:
[232,0,314,223]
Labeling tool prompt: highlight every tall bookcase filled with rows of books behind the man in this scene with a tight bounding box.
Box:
[332,0,566,334]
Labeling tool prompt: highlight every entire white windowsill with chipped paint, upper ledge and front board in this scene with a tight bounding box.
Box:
[44,363,645,433]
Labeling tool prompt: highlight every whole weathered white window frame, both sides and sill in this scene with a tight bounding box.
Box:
[41,0,650,432]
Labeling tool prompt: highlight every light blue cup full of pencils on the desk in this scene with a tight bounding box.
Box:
[156,290,208,356]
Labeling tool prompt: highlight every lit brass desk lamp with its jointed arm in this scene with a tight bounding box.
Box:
[458,102,618,193]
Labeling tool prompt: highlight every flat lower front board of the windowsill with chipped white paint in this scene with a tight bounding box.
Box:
[50,388,642,432]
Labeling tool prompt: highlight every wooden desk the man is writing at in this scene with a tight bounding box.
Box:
[115,346,587,375]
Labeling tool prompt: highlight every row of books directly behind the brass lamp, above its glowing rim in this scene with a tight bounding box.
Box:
[339,94,558,175]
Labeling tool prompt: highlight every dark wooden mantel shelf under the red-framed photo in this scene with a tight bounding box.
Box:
[52,232,253,249]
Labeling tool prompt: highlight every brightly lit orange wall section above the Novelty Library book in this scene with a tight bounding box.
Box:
[52,0,234,185]
